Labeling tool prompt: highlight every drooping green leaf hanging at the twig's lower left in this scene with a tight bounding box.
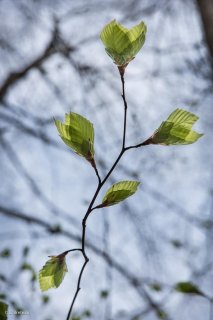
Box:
[39,255,68,291]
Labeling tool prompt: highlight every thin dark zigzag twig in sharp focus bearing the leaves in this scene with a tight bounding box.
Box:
[66,69,130,320]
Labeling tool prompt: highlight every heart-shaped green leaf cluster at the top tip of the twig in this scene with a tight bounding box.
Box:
[100,20,146,66]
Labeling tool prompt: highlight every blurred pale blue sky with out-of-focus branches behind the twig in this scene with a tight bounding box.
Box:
[0,0,213,320]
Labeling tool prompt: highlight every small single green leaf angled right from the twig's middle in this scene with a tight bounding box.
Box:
[100,181,140,207]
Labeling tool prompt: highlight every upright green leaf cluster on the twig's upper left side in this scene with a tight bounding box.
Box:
[55,112,95,163]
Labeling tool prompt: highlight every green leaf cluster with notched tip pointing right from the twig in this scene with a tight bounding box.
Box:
[149,109,203,146]
